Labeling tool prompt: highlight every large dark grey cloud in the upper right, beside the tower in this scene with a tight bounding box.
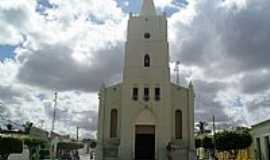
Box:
[171,0,270,76]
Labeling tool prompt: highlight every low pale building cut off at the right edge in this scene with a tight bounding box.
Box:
[251,120,270,160]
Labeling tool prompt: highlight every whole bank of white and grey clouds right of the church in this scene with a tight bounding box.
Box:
[169,0,270,124]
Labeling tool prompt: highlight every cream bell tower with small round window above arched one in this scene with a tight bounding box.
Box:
[123,0,170,83]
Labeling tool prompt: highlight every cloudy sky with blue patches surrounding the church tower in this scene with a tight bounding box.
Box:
[0,0,270,138]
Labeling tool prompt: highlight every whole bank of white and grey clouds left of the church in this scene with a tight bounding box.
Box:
[0,0,126,137]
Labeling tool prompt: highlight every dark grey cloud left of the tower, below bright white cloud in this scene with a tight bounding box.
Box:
[18,44,123,92]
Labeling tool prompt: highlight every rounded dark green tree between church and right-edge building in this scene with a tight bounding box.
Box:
[215,130,252,159]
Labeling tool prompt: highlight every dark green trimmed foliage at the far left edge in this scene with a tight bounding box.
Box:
[0,136,23,155]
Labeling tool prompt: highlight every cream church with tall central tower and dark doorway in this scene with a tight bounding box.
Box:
[97,0,195,160]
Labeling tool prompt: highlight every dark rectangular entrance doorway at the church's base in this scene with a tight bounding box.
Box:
[135,125,155,160]
